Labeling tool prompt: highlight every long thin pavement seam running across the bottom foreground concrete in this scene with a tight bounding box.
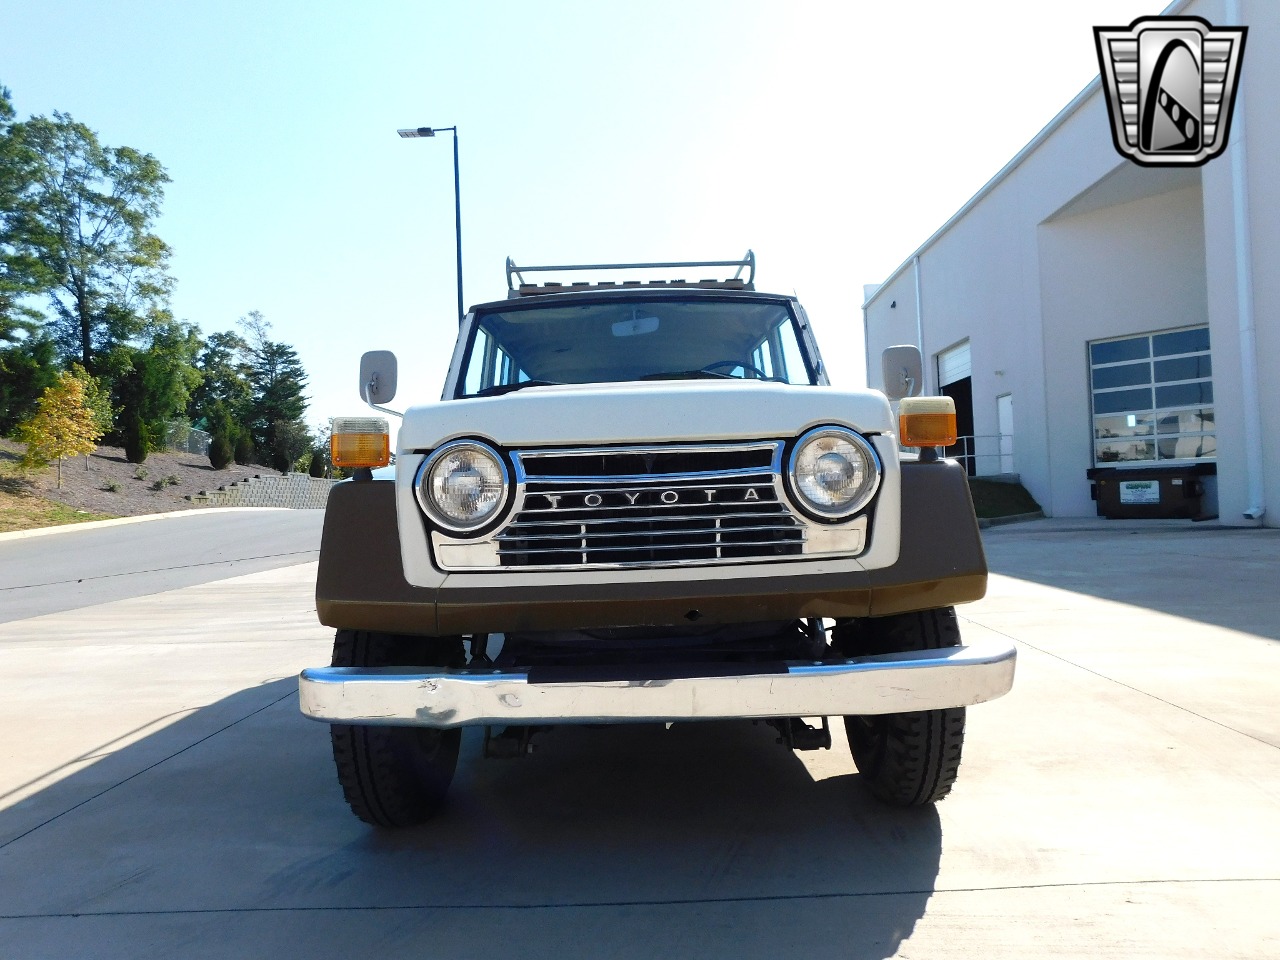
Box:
[0,877,1280,920]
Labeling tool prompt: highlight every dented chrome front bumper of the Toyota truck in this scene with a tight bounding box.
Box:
[298,644,1018,727]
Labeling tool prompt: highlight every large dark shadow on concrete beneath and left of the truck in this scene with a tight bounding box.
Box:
[0,678,942,960]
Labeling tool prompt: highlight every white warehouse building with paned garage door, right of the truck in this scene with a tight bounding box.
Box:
[863,0,1280,526]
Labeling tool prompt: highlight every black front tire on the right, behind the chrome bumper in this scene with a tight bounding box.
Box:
[833,607,964,806]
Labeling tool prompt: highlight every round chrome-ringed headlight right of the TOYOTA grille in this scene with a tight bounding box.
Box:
[788,426,881,520]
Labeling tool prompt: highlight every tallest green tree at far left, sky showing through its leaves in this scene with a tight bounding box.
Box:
[8,108,172,374]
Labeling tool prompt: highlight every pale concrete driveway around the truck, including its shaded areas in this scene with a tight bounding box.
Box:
[0,521,1280,960]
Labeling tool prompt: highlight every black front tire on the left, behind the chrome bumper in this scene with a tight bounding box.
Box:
[329,630,463,827]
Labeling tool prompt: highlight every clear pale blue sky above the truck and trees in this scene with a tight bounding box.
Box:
[0,0,1164,425]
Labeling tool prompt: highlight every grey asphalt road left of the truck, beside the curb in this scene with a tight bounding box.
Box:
[0,508,324,623]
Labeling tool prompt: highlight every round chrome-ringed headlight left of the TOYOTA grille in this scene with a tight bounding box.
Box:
[413,440,508,532]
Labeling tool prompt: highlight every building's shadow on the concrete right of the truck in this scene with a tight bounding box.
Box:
[983,520,1280,640]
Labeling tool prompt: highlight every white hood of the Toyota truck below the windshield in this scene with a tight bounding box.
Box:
[398,380,893,452]
